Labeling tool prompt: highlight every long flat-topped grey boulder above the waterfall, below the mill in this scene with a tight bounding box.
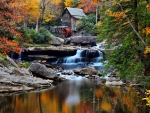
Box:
[65,36,96,46]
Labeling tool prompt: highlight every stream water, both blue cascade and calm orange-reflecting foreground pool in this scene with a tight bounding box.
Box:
[0,44,149,113]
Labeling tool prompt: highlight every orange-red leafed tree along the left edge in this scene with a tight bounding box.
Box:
[0,0,21,54]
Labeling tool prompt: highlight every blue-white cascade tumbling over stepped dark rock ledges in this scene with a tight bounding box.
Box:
[54,49,103,70]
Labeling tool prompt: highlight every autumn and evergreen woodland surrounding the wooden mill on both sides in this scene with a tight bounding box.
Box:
[0,0,150,108]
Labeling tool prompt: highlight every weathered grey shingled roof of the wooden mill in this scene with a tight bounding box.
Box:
[63,7,86,19]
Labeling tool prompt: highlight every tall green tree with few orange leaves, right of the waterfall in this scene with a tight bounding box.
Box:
[99,0,150,81]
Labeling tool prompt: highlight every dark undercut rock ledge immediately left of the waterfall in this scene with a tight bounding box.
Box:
[12,46,76,61]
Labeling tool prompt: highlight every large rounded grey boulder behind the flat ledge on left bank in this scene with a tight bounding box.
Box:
[29,63,57,79]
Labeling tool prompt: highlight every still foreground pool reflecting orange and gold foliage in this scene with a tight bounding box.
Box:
[0,79,148,113]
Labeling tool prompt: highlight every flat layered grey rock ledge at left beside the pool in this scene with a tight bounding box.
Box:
[0,67,53,93]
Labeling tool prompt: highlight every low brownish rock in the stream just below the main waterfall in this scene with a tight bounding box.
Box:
[73,66,100,76]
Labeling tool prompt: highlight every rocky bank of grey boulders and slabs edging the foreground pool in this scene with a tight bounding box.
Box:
[0,54,124,95]
